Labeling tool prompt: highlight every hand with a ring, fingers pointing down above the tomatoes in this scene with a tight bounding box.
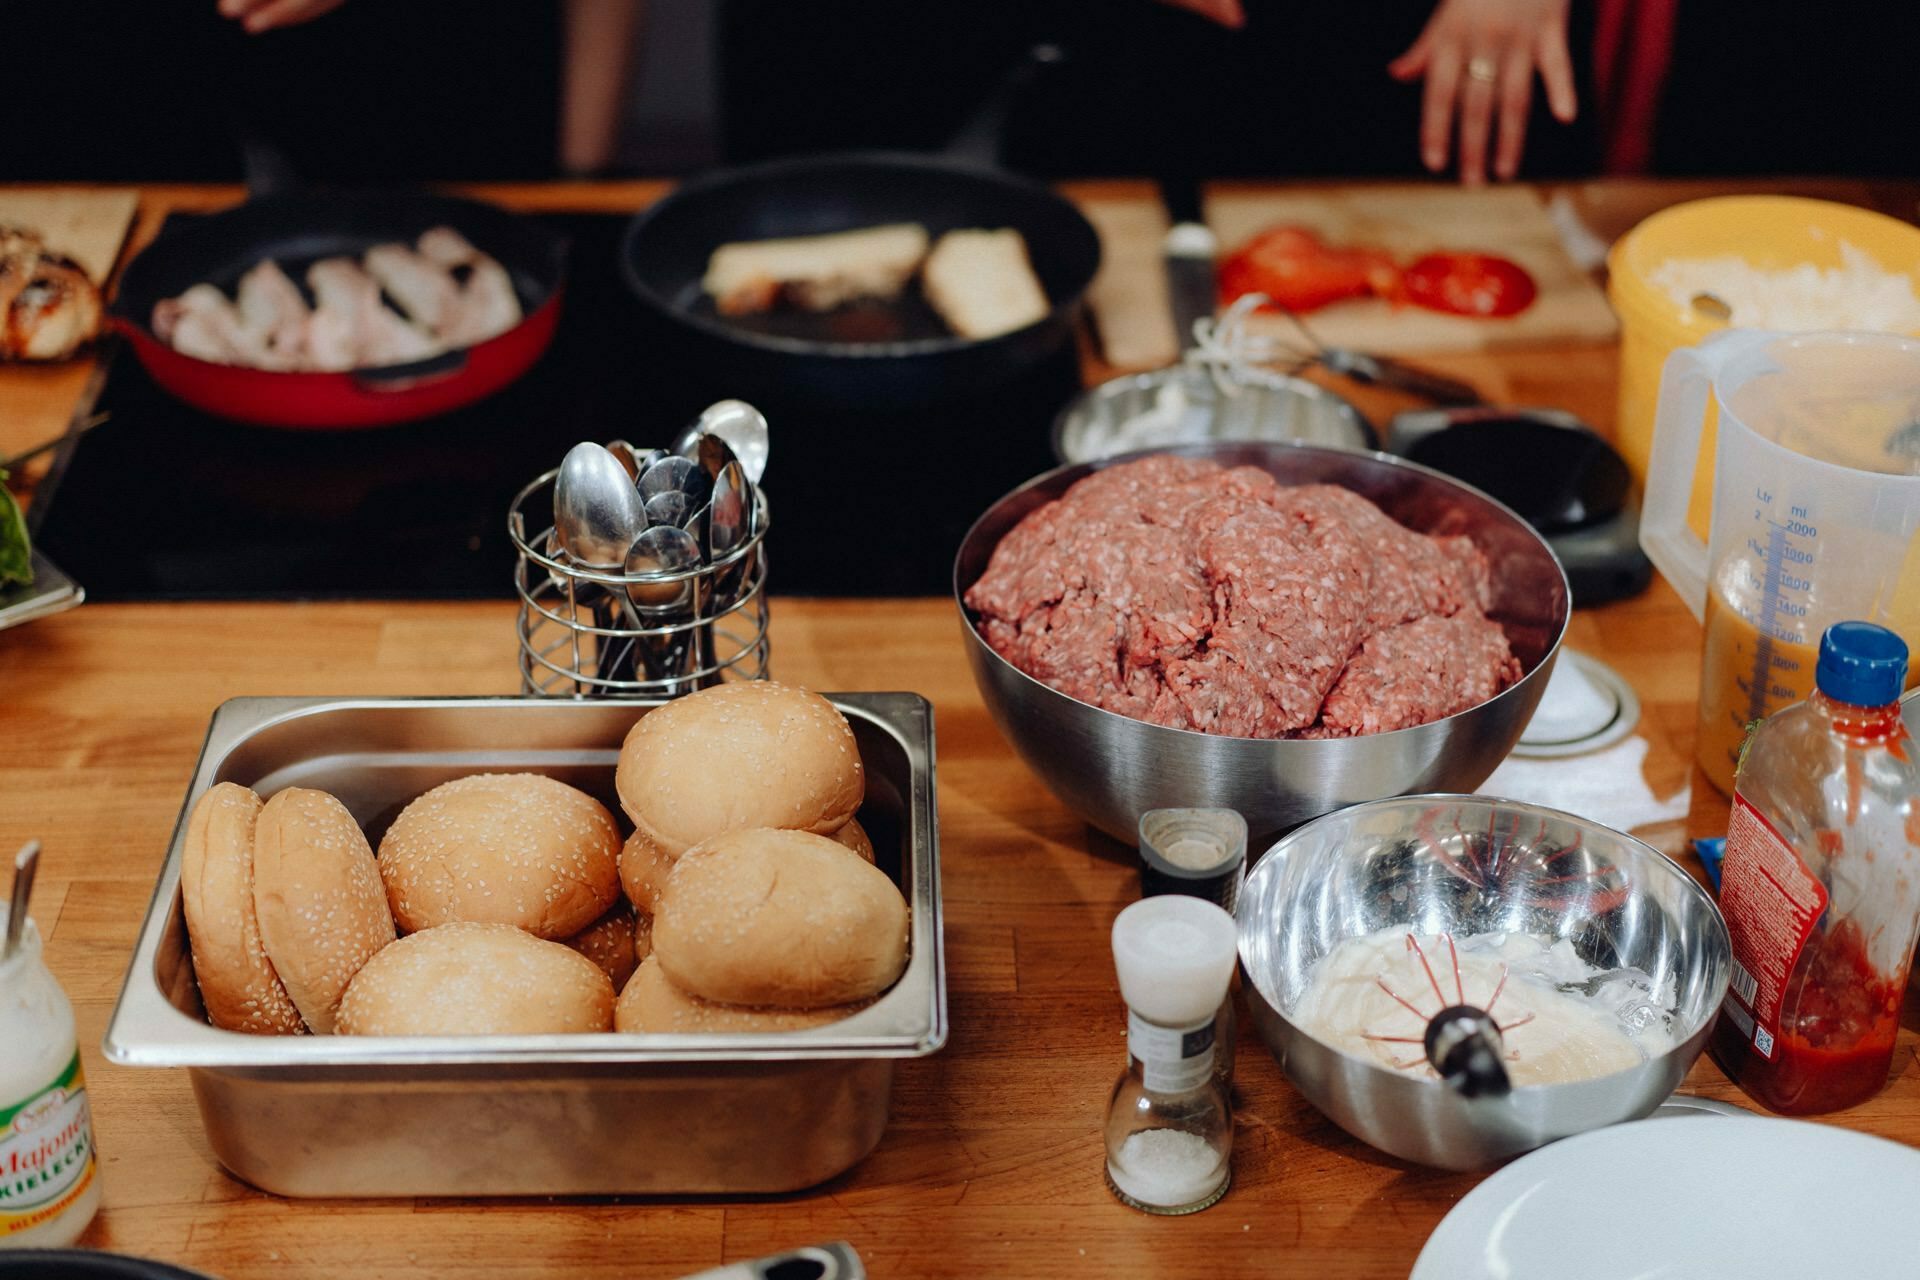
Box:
[1386,0,1576,186]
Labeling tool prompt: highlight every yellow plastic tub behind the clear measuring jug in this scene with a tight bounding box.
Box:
[1607,196,1920,541]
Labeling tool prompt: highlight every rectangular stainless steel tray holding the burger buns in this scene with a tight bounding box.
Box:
[104,693,947,1196]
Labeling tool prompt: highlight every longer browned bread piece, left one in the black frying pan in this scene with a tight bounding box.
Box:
[701,223,927,315]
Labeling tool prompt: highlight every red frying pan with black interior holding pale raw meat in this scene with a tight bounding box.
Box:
[109,190,566,430]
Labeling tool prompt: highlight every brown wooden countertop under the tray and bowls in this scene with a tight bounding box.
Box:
[0,182,1920,1280]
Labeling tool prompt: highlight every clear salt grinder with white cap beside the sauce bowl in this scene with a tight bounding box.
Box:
[1106,894,1238,1215]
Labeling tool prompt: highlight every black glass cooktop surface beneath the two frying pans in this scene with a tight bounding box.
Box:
[33,215,1079,601]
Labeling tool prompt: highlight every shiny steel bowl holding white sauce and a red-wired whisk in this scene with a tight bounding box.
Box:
[1236,794,1732,1169]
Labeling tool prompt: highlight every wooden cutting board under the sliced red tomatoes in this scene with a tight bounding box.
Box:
[1206,186,1619,355]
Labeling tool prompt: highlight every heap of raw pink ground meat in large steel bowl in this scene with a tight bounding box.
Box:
[966,455,1521,737]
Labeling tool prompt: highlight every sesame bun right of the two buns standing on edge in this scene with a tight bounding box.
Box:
[380,773,620,938]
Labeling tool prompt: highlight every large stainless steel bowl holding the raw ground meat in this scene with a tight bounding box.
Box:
[954,443,1569,848]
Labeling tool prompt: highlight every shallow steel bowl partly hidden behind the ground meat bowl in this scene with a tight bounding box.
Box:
[1054,365,1380,464]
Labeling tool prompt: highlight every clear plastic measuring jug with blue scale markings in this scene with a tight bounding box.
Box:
[1640,330,1920,793]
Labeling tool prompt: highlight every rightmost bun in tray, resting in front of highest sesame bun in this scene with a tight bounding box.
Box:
[653,829,906,1009]
